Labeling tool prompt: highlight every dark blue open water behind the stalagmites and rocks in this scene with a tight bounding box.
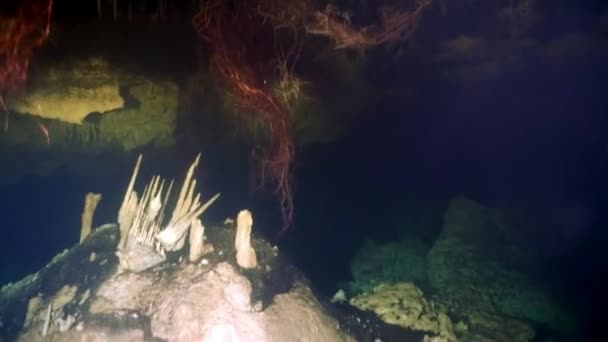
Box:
[0,3,608,340]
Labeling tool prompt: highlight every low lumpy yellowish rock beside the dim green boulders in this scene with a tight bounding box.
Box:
[350,283,456,341]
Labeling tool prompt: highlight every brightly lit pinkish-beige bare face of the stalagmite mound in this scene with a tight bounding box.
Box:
[80,262,343,341]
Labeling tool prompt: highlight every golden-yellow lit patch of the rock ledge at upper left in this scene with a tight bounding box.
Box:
[7,58,124,124]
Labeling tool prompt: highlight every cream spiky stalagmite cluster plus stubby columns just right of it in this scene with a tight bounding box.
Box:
[116,154,257,272]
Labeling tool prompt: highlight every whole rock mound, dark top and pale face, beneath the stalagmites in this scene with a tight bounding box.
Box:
[0,227,352,342]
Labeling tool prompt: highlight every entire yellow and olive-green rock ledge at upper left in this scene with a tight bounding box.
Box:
[0,57,179,150]
